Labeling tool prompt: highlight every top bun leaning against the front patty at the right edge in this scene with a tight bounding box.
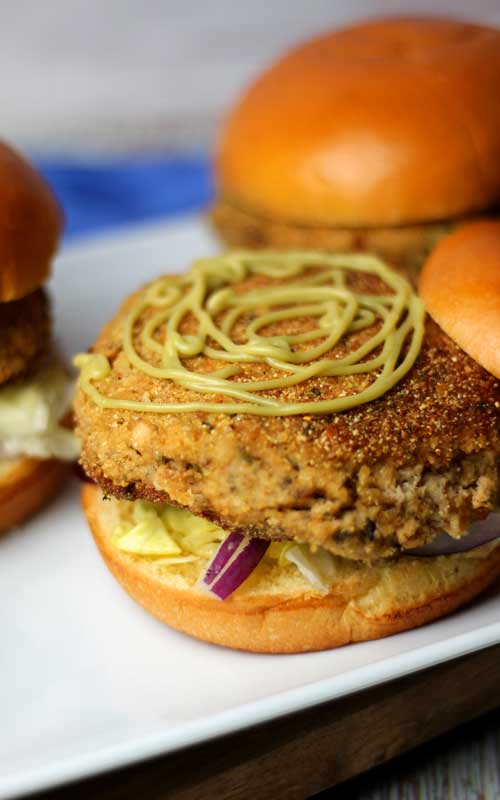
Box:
[419,221,500,378]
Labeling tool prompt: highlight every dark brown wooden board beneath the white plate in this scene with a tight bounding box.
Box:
[38,645,500,800]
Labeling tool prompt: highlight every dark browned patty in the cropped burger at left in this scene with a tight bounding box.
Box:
[0,289,50,384]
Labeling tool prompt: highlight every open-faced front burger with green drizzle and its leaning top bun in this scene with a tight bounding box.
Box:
[76,223,500,653]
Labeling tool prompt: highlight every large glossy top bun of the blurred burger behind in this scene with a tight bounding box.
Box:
[216,17,500,227]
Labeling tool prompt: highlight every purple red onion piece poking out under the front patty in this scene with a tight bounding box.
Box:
[203,533,270,600]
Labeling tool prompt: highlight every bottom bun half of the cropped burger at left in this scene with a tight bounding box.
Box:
[0,458,68,533]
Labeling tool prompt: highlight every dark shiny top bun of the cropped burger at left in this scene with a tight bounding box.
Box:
[0,142,62,303]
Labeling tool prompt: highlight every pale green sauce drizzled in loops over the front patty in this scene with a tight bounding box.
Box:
[75,251,425,416]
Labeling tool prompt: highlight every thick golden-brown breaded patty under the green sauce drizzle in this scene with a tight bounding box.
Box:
[75,266,500,559]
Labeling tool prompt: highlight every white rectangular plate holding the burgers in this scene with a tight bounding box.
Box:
[0,220,500,798]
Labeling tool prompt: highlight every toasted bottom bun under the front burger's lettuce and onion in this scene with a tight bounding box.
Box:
[82,484,500,653]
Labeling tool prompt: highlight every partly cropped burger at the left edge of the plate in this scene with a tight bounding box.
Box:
[0,144,78,531]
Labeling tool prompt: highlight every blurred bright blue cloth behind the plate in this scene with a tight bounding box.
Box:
[35,155,213,238]
